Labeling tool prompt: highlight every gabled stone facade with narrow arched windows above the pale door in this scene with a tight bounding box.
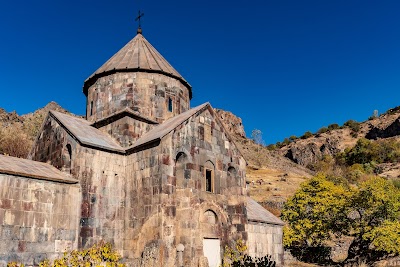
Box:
[155,109,247,266]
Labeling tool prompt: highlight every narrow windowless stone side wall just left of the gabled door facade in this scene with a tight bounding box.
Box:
[123,146,164,267]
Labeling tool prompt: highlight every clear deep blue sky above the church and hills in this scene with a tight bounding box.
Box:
[0,0,400,144]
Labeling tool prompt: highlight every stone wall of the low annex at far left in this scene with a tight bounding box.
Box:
[0,174,81,267]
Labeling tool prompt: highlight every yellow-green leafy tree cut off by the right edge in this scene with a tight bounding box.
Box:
[349,177,400,262]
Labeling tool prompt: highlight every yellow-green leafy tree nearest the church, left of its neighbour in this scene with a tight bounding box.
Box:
[282,174,349,247]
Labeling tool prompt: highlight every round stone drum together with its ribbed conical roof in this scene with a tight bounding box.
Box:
[83,30,192,123]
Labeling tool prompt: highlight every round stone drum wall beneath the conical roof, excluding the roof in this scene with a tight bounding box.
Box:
[86,72,190,122]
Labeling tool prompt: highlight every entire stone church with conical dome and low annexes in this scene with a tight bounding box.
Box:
[0,24,283,267]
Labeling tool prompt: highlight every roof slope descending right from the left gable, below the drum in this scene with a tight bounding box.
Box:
[50,110,125,153]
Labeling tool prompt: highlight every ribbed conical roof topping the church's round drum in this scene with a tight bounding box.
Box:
[83,32,192,98]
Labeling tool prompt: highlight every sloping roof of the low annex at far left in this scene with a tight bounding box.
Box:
[0,155,78,184]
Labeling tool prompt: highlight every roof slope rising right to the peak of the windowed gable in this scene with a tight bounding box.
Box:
[128,102,210,149]
